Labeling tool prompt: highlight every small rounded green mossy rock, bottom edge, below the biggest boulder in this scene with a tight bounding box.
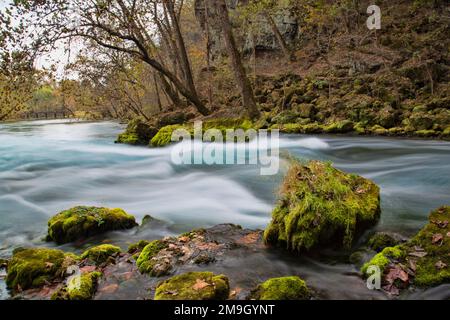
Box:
[250,276,311,300]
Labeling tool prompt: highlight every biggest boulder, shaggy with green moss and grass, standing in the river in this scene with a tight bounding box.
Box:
[264,161,380,252]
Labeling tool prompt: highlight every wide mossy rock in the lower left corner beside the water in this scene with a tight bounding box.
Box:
[6,248,75,290]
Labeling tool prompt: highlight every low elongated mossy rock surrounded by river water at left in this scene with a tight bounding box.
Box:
[47,207,137,244]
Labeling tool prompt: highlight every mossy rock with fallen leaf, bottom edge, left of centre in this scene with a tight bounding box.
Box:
[155,272,230,300]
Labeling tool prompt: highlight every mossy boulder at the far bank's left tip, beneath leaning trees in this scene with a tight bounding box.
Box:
[116,118,158,145]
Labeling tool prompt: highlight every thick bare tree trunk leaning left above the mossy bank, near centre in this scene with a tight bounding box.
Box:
[213,0,260,119]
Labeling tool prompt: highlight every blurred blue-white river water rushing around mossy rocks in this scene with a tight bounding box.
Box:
[0,120,450,299]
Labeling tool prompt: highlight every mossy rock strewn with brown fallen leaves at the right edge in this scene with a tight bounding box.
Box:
[361,206,450,291]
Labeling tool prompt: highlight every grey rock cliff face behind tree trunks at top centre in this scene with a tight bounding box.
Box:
[195,0,299,59]
